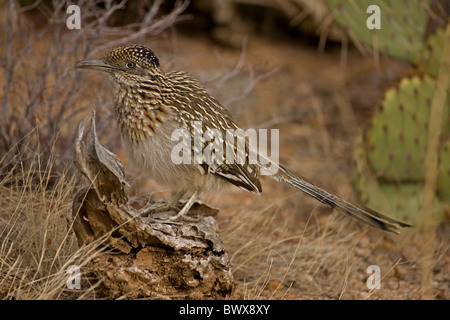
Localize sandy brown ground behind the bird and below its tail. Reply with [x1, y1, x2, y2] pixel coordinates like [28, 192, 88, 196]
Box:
[120, 33, 450, 299]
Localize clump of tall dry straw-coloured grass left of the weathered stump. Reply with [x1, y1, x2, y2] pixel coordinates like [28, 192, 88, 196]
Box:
[0, 141, 100, 299]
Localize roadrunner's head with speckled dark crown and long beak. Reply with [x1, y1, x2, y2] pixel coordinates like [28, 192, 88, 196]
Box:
[76, 45, 160, 85]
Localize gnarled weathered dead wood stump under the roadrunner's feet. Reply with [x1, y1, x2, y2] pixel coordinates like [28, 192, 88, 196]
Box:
[72, 112, 234, 299]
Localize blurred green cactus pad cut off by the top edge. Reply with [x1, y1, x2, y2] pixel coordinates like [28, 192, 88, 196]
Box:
[325, 0, 430, 62]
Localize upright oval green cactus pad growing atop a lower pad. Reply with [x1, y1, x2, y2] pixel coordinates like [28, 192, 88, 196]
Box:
[366, 76, 448, 181]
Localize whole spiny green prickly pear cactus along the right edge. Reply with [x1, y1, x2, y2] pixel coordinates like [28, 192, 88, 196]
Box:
[325, 0, 450, 223]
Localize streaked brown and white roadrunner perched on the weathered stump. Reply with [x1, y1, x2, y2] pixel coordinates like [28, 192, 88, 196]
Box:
[77, 45, 409, 233]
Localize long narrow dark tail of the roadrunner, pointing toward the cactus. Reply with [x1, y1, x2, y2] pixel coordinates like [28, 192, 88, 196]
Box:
[264, 163, 411, 234]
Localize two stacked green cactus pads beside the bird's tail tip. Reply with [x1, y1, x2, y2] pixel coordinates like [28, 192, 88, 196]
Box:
[354, 76, 450, 223]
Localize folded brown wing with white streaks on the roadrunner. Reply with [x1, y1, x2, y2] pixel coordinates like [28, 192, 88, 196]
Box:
[171, 72, 262, 193]
